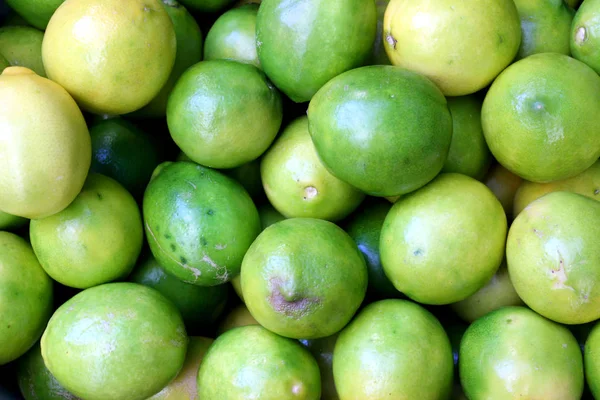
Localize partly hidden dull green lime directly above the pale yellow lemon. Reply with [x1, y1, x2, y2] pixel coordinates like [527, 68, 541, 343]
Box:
[0, 26, 46, 78]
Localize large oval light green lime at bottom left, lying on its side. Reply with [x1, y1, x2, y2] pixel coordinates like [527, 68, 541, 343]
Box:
[41, 282, 188, 400]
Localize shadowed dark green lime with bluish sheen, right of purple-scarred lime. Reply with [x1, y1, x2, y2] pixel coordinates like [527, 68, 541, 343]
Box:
[345, 197, 400, 298]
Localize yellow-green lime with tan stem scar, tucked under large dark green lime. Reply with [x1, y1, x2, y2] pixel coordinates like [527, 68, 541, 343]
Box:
[260, 116, 365, 221]
